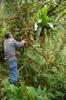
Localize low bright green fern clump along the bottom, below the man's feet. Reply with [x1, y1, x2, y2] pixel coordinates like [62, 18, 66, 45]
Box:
[3, 81, 54, 100]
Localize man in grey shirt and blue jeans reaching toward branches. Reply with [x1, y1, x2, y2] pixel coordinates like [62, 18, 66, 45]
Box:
[4, 32, 26, 84]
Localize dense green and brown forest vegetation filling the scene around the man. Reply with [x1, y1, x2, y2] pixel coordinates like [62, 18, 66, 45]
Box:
[0, 0, 66, 100]
